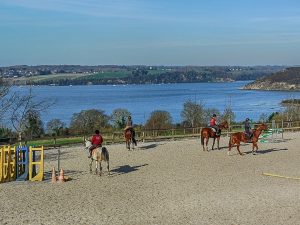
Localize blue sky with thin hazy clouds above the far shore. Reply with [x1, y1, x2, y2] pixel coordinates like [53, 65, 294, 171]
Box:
[0, 0, 300, 66]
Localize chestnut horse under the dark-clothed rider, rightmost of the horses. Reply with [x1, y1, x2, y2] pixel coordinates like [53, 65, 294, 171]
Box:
[228, 123, 268, 155]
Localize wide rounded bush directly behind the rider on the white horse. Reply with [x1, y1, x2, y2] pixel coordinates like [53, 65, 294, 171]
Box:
[70, 109, 109, 135]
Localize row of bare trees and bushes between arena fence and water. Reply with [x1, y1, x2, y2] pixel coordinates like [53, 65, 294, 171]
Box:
[0, 77, 300, 141]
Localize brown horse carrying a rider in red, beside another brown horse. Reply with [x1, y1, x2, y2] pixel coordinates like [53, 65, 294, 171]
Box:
[201, 120, 228, 151]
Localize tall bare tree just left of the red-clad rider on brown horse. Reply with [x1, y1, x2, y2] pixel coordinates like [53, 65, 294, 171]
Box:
[181, 100, 204, 127]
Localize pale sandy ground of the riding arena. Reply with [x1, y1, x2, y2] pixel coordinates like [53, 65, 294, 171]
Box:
[0, 132, 300, 225]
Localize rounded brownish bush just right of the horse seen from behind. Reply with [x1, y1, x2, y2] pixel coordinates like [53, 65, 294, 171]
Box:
[145, 110, 172, 129]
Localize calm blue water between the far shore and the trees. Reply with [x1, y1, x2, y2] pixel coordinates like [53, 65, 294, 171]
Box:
[11, 82, 300, 125]
